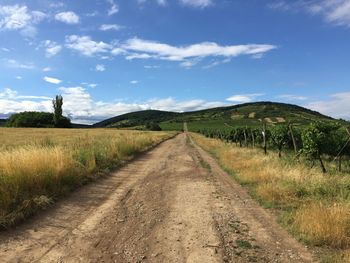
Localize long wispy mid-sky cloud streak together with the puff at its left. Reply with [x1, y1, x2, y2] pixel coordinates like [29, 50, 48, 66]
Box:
[65, 35, 277, 67]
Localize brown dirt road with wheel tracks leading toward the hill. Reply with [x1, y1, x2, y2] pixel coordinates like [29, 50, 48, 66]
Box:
[0, 133, 314, 263]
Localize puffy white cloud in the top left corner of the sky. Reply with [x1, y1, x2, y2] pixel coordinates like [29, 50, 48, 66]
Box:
[0, 5, 47, 37]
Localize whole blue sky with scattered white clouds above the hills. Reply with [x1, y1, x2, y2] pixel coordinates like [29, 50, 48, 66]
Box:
[0, 0, 350, 123]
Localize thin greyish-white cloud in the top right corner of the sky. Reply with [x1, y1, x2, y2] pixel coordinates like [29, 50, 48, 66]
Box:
[268, 0, 350, 27]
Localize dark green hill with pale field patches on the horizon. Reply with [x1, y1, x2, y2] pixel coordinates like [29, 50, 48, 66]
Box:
[93, 102, 342, 131]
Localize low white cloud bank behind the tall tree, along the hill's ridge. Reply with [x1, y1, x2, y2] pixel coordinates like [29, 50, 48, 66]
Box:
[0, 87, 227, 123]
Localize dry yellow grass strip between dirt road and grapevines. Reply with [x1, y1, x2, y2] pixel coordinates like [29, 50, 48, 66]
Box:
[191, 134, 350, 262]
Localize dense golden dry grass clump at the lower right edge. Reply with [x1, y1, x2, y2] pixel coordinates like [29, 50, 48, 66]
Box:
[293, 203, 350, 248]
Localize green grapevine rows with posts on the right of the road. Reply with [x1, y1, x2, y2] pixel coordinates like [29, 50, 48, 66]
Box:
[198, 122, 350, 173]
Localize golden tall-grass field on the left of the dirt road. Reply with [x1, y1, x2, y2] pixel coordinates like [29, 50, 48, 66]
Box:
[0, 128, 175, 227]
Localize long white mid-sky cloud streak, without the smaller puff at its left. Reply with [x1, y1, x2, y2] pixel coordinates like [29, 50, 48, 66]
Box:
[121, 38, 277, 66]
